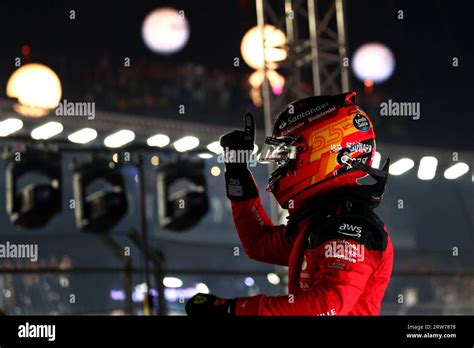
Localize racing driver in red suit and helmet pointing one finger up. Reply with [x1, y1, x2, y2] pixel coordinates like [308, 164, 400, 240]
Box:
[186, 92, 393, 317]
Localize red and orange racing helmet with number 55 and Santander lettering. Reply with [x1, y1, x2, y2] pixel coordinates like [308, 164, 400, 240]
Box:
[259, 92, 388, 208]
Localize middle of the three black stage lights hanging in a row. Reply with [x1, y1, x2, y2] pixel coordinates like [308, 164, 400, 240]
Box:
[73, 158, 128, 233]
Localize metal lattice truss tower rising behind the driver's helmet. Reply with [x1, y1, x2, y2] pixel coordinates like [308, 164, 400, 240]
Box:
[256, 0, 350, 293]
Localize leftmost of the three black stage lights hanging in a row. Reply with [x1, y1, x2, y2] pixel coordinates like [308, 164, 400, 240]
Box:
[5, 150, 62, 228]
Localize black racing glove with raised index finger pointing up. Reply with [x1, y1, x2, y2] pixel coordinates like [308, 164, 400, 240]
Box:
[220, 112, 258, 201]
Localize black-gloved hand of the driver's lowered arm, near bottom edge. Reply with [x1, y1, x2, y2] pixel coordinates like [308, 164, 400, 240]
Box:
[185, 293, 234, 317]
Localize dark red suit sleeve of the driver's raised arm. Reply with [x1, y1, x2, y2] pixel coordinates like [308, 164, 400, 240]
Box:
[231, 196, 294, 266]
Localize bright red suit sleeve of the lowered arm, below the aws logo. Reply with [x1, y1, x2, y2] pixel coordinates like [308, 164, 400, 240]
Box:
[235, 222, 383, 316]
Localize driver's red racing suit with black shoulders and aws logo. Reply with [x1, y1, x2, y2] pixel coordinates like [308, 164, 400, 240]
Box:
[231, 197, 393, 316]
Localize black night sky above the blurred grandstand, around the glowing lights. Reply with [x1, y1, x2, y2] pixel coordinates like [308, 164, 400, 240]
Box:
[0, 0, 474, 151]
